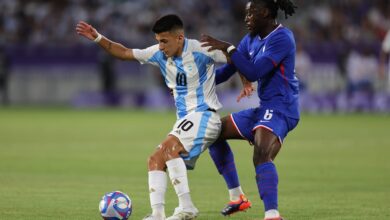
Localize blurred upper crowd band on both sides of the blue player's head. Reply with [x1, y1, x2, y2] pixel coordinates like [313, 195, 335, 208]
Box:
[0, 0, 390, 45]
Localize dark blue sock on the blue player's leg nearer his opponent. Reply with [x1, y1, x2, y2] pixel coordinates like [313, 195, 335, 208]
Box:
[209, 141, 240, 189]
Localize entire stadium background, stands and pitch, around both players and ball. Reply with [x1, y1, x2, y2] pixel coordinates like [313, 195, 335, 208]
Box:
[0, 0, 390, 220]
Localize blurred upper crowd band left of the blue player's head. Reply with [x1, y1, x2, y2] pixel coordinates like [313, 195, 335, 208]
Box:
[0, 0, 243, 46]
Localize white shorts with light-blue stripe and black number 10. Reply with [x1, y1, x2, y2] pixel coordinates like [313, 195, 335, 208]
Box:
[169, 111, 222, 169]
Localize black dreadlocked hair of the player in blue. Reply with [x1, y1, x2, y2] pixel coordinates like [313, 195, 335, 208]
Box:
[249, 0, 297, 19]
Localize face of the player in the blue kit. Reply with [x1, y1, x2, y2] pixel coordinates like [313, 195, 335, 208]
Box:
[245, 2, 267, 34]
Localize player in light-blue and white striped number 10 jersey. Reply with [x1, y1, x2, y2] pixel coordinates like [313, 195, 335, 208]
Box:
[76, 15, 250, 220]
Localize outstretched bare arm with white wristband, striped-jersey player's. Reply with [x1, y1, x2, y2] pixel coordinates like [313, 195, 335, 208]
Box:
[76, 21, 135, 60]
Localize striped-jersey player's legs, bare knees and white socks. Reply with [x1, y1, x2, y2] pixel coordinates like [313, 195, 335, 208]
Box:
[146, 135, 198, 219]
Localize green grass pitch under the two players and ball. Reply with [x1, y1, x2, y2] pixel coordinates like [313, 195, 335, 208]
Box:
[0, 108, 390, 220]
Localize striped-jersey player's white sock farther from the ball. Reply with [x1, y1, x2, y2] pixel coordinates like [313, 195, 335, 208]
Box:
[166, 158, 194, 209]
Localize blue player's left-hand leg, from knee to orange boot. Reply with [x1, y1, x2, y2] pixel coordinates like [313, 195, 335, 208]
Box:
[209, 116, 251, 216]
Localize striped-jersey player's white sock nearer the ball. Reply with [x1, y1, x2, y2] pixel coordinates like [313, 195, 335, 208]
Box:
[148, 170, 167, 218]
